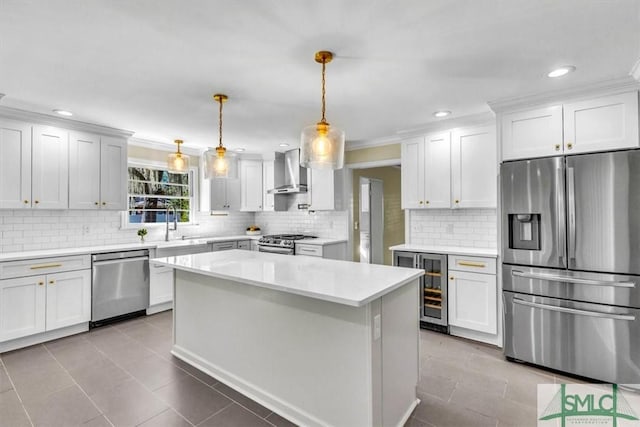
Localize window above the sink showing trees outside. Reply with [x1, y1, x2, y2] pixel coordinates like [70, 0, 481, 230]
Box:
[127, 165, 194, 224]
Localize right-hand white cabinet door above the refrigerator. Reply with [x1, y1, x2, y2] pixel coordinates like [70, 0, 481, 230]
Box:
[564, 91, 639, 154]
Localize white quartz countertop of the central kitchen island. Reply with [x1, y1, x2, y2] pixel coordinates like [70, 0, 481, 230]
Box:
[151, 249, 424, 307]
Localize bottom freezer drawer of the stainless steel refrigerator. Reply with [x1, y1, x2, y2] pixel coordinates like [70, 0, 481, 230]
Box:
[503, 291, 640, 384]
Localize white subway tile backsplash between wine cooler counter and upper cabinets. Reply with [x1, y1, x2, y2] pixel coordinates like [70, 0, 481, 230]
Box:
[409, 209, 498, 248]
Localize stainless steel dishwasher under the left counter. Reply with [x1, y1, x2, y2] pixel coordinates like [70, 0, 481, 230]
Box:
[91, 249, 149, 326]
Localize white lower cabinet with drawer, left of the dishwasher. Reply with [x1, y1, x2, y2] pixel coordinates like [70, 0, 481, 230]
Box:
[0, 257, 91, 342]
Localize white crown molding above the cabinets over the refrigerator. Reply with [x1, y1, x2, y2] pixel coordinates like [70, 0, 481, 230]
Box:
[487, 75, 640, 113]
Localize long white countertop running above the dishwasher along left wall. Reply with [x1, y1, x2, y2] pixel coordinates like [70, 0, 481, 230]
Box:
[0, 234, 261, 262]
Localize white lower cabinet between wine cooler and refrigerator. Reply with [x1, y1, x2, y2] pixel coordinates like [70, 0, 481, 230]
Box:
[447, 255, 498, 334]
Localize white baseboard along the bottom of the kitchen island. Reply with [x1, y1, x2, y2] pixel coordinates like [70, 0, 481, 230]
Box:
[171, 345, 330, 426]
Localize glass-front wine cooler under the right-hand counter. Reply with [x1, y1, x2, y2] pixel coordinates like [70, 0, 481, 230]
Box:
[393, 252, 449, 333]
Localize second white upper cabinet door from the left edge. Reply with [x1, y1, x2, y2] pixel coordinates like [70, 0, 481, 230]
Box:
[31, 126, 69, 209]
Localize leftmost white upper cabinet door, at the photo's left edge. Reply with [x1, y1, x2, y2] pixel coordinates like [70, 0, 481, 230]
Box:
[0, 119, 31, 209]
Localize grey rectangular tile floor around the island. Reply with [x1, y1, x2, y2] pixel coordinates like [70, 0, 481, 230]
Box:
[0, 312, 584, 427]
